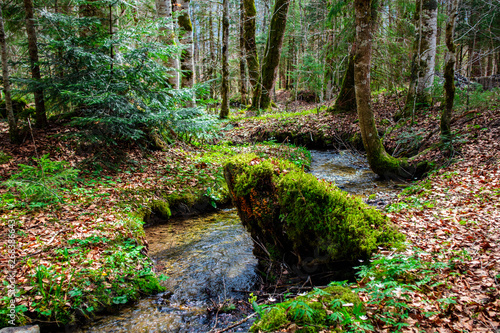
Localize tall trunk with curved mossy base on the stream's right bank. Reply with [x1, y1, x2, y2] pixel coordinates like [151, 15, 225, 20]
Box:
[354, 0, 411, 178]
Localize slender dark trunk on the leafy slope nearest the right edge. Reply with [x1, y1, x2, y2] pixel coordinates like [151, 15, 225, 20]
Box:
[441, 0, 458, 143]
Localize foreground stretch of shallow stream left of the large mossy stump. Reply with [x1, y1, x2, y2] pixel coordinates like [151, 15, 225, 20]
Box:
[80, 209, 257, 333]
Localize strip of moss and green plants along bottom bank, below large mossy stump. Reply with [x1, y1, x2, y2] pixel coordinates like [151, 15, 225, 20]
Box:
[254, 248, 468, 332]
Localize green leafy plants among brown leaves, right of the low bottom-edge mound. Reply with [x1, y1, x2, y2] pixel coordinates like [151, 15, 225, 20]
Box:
[354, 248, 460, 332]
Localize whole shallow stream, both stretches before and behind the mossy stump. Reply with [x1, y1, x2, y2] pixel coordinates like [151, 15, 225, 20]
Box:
[77, 151, 397, 333]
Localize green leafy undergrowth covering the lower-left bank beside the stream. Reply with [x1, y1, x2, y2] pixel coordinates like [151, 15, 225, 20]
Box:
[0, 213, 164, 327]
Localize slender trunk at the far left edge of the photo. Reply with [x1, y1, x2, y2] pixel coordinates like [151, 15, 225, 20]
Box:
[0, 6, 19, 143]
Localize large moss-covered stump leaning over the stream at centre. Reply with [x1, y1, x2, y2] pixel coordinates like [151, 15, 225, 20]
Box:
[224, 154, 404, 272]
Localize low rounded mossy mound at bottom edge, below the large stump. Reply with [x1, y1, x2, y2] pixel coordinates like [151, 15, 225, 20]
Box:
[250, 286, 364, 332]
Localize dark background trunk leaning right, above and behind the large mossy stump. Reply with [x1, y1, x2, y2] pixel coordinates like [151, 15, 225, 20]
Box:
[252, 0, 290, 109]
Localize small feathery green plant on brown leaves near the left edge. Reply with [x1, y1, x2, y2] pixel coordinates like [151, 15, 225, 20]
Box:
[3, 154, 80, 203]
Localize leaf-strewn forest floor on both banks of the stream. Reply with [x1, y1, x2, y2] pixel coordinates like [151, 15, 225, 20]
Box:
[0, 89, 500, 333]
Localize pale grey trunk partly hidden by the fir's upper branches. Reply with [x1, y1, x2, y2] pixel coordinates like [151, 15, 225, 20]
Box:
[156, 0, 179, 89]
